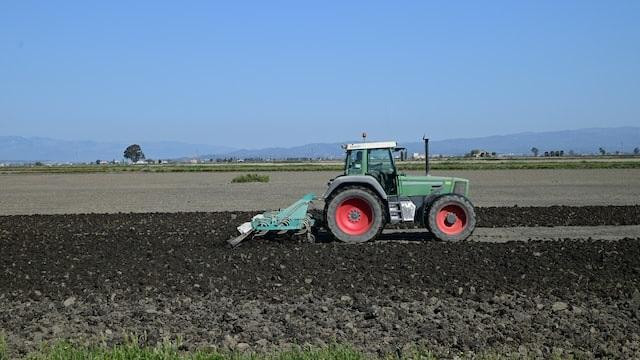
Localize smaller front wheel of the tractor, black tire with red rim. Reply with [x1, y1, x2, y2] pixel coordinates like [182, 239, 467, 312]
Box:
[425, 194, 476, 241]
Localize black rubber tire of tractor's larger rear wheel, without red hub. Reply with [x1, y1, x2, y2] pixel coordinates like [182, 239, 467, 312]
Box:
[324, 186, 386, 243]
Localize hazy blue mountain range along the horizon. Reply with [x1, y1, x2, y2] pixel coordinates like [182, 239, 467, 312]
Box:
[0, 127, 640, 162]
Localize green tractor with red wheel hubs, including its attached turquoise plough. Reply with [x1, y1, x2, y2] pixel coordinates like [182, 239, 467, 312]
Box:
[229, 139, 476, 246]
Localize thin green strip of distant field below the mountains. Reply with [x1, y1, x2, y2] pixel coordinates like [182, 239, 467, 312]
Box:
[0, 157, 640, 174]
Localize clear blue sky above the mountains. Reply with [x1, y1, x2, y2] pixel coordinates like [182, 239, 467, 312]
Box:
[0, 0, 640, 148]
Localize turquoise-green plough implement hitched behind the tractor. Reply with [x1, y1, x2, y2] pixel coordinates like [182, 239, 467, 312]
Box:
[227, 193, 316, 247]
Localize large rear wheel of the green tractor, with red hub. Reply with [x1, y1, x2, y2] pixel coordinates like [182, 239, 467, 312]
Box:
[325, 187, 385, 243]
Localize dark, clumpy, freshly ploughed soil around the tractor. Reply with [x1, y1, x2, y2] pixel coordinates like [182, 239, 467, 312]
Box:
[0, 207, 640, 357]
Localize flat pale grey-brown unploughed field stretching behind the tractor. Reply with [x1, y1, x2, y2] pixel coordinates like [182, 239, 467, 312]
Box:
[0, 169, 640, 215]
